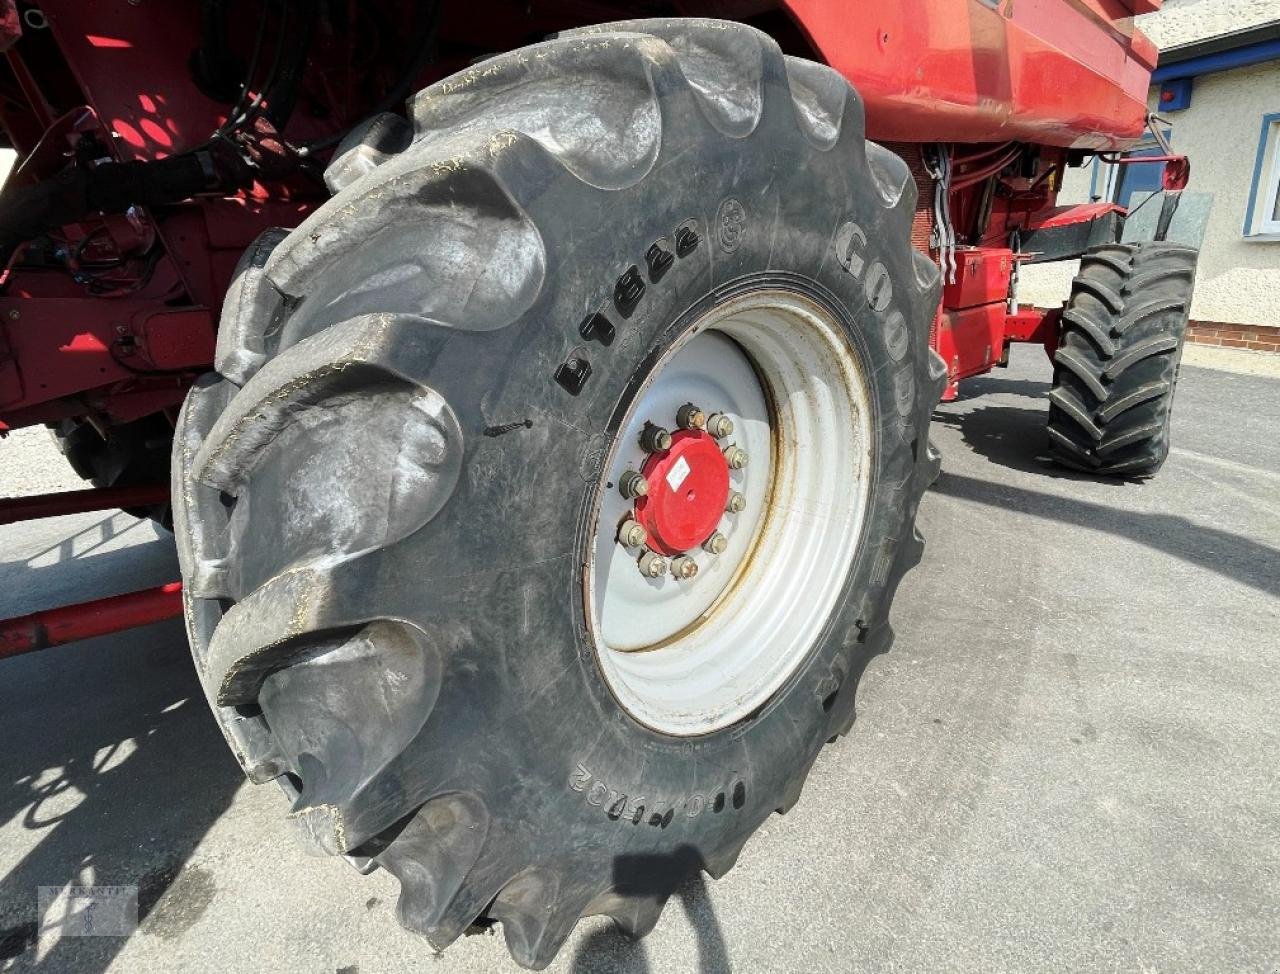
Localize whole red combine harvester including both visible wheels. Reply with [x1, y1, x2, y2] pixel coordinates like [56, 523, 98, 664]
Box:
[0, 0, 1196, 968]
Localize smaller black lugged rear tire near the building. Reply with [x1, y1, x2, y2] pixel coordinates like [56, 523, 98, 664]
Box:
[1048, 243, 1198, 476]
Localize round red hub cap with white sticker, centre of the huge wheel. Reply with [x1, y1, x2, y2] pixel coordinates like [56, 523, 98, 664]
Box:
[636, 430, 728, 555]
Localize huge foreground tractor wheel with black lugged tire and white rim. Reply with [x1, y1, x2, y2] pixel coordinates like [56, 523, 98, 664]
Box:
[174, 20, 945, 968]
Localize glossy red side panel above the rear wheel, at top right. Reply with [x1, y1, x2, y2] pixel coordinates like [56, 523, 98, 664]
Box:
[786, 0, 1158, 148]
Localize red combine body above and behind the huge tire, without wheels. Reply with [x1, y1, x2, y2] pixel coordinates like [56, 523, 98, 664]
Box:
[0, 0, 1160, 645]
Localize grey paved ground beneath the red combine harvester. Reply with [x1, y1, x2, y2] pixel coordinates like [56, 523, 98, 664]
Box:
[0, 349, 1280, 974]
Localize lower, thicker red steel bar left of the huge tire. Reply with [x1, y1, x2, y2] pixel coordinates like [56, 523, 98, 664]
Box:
[0, 581, 182, 659]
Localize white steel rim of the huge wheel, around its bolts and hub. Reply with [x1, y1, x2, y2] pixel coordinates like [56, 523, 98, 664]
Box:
[585, 289, 874, 736]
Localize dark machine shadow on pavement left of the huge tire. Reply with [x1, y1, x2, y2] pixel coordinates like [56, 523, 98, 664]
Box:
[0, 515, 244, 973]
